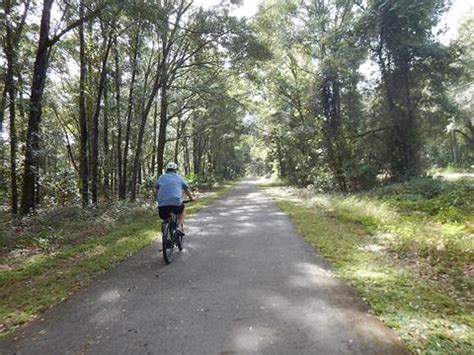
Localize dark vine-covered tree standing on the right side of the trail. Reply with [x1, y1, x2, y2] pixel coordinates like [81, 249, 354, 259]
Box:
[365, 0, 446, 180]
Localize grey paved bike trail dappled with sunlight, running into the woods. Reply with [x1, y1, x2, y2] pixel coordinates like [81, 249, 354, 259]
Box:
[0, 182, 407, 355]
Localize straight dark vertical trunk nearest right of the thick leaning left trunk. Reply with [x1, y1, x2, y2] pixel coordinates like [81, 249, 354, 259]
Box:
[79, 1, 89, 207]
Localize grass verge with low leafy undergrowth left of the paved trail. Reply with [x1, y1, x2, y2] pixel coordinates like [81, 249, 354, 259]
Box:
[0, 184, 232, 337]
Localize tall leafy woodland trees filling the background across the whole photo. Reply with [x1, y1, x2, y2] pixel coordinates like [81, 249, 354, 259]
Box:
[0, 0, 474, 214]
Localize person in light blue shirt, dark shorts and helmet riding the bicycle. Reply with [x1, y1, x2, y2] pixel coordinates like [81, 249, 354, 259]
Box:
[155, 162, 194, 234]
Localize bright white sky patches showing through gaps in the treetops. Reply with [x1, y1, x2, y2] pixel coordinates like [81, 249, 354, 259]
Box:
[194, 0, 474, 44]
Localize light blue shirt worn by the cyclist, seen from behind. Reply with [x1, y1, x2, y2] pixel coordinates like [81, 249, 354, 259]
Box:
[155, 173, 189, 207]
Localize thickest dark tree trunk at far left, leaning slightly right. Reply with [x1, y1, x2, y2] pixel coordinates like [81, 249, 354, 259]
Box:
[21, 0, 53, 214]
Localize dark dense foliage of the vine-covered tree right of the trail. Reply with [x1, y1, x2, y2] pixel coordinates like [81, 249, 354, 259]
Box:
[363, 0, 453, 180]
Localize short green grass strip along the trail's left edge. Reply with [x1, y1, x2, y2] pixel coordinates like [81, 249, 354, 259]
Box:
[0, 184, 233, 337]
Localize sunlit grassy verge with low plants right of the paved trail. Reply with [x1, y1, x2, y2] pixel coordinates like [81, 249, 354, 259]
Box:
[267, 179, 474, 354]
